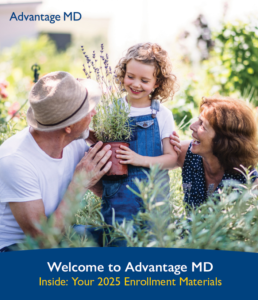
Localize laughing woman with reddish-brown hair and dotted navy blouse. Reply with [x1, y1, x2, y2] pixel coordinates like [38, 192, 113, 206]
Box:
[171, 97, 258, 207]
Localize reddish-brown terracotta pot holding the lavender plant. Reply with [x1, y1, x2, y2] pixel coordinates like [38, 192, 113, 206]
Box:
[103, 142, 129, 180]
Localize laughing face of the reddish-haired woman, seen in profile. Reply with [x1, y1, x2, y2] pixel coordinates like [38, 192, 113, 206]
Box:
[190, 113, 215, 156]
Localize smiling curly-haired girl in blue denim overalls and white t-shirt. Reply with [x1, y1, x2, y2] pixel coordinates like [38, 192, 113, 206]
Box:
[102, 43, 177, 230]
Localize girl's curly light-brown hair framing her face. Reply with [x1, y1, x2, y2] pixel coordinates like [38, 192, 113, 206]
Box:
[115, 43, 178, 102]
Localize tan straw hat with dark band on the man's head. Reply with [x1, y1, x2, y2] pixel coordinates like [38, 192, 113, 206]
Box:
[27, 71, 101, 131]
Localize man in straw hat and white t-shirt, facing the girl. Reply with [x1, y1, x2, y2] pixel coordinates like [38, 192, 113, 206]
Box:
[0, 72, 111, 252]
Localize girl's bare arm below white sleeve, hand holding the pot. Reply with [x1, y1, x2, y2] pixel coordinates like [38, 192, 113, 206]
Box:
[116, 138, 178, 169]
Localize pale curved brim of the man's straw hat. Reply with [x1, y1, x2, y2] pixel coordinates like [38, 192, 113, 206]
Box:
[27, 78, 101, 131]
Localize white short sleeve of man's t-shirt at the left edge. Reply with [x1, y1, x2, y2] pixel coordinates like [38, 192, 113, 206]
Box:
[0, 155, 42, 202]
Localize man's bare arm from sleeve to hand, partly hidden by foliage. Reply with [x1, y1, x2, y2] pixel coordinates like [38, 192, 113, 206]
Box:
[9, 142, 112, 238]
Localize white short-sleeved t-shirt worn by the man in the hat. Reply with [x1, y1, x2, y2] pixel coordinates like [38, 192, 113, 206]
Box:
[0, 127, 88, 249]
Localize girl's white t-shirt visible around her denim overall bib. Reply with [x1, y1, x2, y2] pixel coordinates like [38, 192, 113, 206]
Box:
[123, 97, 175, 151]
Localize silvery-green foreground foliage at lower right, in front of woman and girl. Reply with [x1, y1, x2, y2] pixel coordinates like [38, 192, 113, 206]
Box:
[105, 168, 258, 252]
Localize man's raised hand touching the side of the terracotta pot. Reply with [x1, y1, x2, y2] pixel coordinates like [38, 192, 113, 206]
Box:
[74, 142, 112, 189]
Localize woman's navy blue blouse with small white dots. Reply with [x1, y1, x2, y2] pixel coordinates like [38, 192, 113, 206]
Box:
[182, 143, 258, 207]
